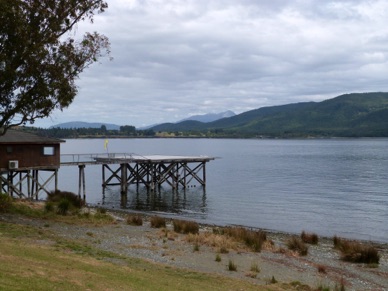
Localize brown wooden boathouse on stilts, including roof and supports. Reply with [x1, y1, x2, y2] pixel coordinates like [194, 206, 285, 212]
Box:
[0, 130, 64, 199]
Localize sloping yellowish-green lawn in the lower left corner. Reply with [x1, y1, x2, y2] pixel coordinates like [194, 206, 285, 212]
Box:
[0, 222, 264, 290]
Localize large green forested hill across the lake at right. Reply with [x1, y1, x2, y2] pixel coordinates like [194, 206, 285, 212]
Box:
[152, 92, 388, 137]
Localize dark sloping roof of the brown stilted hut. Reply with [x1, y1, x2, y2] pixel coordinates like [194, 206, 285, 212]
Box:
[0, 129, 65, 144]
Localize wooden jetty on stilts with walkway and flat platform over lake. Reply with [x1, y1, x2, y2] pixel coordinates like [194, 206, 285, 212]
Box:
[61, 153, 215, 198]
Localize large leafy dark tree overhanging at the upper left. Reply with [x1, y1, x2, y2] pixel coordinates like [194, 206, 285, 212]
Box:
[0, 0, 110, 135]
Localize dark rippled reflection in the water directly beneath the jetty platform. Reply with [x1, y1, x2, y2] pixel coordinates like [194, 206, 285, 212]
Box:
[102, 186, 207, 218]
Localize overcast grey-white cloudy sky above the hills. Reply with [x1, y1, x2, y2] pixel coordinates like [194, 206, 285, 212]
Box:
[35, 0, 388, 127]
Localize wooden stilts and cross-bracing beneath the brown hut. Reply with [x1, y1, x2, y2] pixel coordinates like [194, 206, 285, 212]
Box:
[0, 169, 58, 200]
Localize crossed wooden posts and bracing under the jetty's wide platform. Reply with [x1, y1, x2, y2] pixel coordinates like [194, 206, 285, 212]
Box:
[102, 160, 206, 192]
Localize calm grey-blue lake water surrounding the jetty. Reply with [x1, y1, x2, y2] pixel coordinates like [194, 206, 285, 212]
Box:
[55, 139, 388, 242]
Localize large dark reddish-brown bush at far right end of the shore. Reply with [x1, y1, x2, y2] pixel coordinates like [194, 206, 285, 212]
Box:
[333, 236, 380, 264]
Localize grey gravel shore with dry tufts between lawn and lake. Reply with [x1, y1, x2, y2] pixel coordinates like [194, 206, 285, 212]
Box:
[0, 211, 388, 290]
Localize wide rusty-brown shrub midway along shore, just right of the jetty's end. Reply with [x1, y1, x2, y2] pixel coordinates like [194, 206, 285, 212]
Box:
[224, 227, 267, 252]
